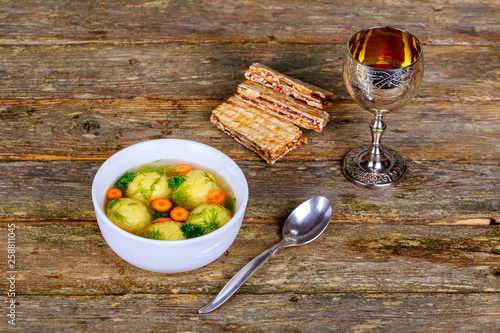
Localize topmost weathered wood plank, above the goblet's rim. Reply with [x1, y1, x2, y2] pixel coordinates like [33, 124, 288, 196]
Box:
[0, 0, 499, 45]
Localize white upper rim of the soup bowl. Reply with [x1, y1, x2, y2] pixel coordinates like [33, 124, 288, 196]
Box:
[92, 139, 248, 247]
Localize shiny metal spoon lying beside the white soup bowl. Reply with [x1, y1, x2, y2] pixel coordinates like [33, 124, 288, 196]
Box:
[198, 197, 332, 313]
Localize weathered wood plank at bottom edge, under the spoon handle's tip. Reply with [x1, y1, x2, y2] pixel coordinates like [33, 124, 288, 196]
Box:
[0, 292, 500, 333]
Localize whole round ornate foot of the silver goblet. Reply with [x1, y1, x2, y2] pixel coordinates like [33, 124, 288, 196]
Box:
[342, 145, 406, 188]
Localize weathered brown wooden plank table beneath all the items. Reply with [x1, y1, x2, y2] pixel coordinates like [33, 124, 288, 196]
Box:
[0, 0, 500, 332]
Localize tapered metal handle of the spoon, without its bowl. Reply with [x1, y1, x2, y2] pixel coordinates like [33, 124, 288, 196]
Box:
[198, 245, 277, 313]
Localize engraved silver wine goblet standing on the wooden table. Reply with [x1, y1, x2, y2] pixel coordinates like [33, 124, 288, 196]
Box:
[342, 27, 424, 188]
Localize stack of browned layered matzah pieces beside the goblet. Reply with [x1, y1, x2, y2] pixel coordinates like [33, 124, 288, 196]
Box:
[210, 64, 335, 164]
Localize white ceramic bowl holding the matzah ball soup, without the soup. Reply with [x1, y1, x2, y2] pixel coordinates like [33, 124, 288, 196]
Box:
[92, 139, 248, 273]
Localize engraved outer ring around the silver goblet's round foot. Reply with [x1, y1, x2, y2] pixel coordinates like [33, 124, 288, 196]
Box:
[342, 146, 406, 187]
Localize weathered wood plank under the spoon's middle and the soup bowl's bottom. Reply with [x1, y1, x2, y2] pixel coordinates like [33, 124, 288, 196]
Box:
[0, 221, 500, 295]
